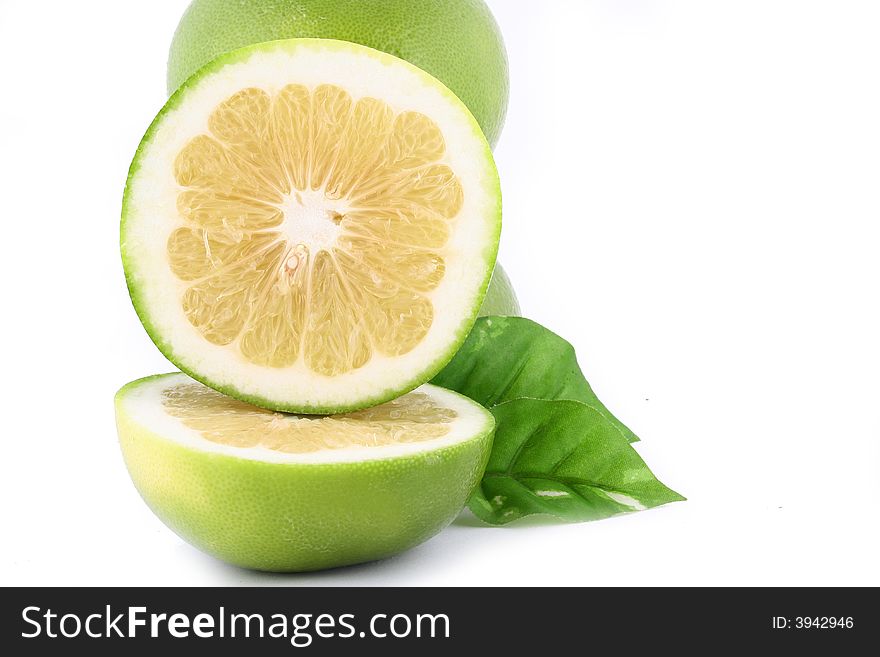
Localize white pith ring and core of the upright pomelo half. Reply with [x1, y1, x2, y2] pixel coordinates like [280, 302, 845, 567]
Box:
[123, 42, 499, 408]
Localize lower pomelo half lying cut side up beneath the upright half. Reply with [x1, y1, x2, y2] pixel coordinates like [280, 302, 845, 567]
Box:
[116, 374, 495, 572]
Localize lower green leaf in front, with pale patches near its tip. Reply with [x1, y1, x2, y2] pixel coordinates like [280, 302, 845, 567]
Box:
[468, 399, 685, 525]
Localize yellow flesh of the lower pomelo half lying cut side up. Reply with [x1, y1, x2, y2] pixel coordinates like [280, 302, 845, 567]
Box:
[162, 383, 458, 454]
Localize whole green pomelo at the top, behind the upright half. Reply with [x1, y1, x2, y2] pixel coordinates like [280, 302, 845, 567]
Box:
[168, 0, 509, 146]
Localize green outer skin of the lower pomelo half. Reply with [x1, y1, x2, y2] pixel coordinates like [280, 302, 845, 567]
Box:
[116, 382, 494, 572]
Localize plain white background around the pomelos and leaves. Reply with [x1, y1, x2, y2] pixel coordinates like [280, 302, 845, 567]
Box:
[0, 0, 880, 586]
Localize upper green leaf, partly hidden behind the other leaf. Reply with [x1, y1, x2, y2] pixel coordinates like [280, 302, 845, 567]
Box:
[432, 317, 638, 442]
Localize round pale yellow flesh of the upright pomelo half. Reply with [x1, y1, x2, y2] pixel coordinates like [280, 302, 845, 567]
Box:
[167, 85, 464, 376]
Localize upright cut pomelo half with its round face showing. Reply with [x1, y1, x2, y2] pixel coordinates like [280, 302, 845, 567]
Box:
[121, 39, 501, 413]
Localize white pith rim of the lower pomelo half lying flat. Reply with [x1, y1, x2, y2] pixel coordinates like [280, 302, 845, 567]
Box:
[119, 374, 493, 464]
